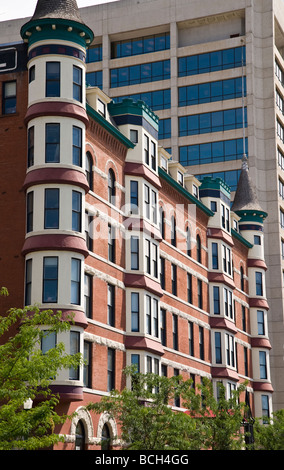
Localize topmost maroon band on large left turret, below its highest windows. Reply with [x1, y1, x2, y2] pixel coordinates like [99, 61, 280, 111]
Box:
[25, 101, 89, 127]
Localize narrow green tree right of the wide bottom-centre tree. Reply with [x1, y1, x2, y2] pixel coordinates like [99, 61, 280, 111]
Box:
[184, 378, 246, 450]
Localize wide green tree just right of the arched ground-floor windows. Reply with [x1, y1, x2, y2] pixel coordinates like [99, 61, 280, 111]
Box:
[87, 368, 200, 451]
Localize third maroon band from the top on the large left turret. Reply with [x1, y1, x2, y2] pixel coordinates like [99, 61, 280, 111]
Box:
[22, 233, 89, 258]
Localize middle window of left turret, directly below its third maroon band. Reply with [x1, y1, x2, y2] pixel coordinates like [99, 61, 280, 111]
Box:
[42, 256, 58, 303]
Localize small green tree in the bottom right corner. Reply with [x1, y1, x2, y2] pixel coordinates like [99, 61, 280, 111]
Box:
[254, 409, 284, 450]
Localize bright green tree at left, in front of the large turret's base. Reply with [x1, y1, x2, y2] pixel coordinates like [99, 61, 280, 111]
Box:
[0, 288, 82, 450]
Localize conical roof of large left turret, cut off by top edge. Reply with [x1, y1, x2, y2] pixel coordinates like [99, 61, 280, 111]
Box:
[31, 0, 83, 23]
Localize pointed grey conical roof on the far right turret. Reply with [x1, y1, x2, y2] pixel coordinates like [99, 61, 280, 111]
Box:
[232, 155, 263, 212]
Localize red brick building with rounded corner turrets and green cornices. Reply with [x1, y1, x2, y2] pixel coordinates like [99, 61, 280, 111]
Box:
[0, 1, 273, 449]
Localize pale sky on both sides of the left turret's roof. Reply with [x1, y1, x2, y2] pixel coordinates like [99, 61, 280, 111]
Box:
[0, 0, 117, 21]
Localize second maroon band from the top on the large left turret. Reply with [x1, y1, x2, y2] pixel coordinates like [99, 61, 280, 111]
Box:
[23, 167, 90, 193]
